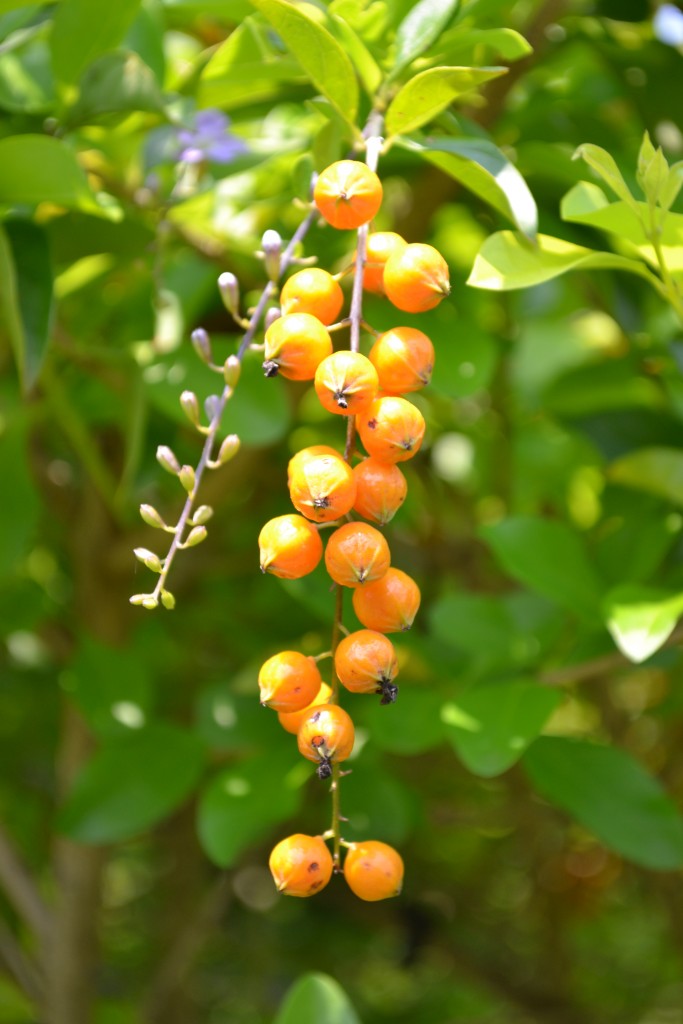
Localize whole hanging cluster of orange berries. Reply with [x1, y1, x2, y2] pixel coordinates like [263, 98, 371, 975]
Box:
[253, 160, 450, 900]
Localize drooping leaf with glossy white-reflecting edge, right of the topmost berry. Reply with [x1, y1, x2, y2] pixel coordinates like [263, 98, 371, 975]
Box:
[401, 136, 538, 238]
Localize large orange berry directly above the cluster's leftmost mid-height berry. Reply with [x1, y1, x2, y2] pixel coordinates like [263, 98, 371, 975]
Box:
[289, 454, 355, 522]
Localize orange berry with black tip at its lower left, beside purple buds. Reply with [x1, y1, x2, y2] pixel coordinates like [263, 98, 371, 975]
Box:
[263, 313, 332, 381]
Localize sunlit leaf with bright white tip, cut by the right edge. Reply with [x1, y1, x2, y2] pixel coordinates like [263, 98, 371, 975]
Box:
[604, 584, 683, 664]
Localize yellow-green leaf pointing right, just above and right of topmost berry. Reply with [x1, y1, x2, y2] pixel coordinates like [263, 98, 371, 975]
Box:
[385, 68, 508, 137]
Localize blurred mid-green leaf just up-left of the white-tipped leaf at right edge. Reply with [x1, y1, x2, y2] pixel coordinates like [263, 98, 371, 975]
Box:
[479, 516, 602, 618]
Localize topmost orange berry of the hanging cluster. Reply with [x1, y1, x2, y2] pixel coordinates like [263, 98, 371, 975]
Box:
[313, 160, 382, 228]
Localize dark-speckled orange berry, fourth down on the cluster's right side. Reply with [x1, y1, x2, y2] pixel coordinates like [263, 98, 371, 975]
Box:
[355, 395, 425, 463]
